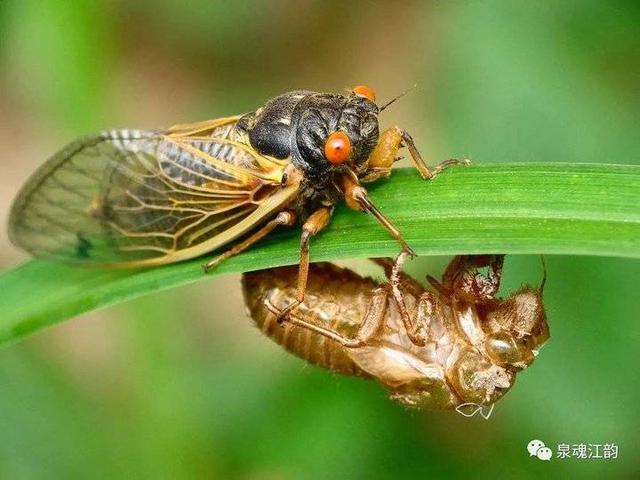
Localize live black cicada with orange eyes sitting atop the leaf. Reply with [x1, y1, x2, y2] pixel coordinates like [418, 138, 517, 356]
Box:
[9, 86, 459, 318]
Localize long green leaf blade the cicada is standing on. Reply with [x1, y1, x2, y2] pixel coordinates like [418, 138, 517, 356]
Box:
[0, 163, 640, 345]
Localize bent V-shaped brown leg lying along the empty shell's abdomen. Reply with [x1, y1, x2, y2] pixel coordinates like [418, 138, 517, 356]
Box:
[264, 286, 389, 348]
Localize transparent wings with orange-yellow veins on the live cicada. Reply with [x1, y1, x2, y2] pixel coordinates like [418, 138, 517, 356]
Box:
[9, 117, 297, 266]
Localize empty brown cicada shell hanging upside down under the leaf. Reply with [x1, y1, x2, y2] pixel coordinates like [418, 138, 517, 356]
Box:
[242, 253, 549, 414]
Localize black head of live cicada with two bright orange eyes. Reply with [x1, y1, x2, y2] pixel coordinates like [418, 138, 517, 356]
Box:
[291, 86, 379, 179]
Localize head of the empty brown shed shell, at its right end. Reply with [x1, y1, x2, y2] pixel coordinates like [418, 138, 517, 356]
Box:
[485, 287, 549, 369]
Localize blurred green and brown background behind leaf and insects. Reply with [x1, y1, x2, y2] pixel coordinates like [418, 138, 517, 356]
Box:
[0, 0, 640, 479]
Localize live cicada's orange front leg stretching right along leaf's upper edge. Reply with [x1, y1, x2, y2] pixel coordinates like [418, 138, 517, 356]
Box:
[361, 126, 471, 182]
